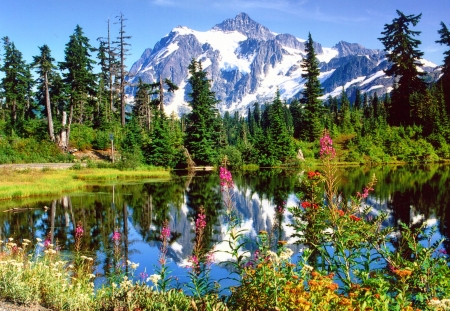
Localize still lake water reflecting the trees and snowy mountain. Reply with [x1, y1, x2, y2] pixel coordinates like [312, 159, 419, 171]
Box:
[0, 165, 450, 287]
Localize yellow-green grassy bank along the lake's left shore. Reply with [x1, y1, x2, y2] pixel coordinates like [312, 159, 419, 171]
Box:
[0, 168, 170, 200]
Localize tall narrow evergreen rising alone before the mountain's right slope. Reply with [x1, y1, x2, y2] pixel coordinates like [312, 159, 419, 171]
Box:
[300, 33, 322, 141]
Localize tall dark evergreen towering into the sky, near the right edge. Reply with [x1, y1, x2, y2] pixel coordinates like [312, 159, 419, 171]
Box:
[379, 10, 426, 125]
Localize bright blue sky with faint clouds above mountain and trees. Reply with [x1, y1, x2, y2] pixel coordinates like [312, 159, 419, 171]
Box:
[0, 0, 450, 67]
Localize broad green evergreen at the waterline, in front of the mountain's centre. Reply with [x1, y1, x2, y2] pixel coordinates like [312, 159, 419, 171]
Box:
[185, 59, 219, 164]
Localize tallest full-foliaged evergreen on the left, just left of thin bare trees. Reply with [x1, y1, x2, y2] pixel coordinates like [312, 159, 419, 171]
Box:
[59, 25, 95, 144]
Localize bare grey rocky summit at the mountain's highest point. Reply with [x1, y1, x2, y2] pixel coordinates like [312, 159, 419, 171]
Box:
[213, 13, 275, 40]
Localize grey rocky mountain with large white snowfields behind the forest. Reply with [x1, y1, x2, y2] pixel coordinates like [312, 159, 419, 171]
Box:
[129, 13, 437, 114]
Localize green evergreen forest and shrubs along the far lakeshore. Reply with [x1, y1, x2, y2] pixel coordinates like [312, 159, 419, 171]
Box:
[0, 11, 450, 168]
